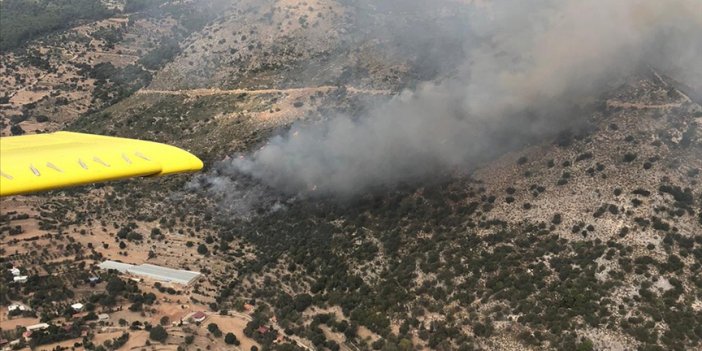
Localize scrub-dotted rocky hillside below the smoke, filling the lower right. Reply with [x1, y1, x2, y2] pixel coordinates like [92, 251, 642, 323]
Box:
[177, 70, 702, 349]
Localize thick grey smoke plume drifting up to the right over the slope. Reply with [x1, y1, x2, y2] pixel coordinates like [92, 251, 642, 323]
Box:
[220, 0, 702, 196]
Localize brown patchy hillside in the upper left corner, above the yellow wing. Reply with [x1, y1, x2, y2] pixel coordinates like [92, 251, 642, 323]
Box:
[0, 0, 224, 135]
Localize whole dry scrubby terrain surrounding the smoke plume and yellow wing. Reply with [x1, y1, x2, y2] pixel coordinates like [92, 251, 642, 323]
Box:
[0, 0, 702, 351]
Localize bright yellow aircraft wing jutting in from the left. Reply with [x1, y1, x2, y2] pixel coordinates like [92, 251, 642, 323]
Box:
[0, 132, 202, 196]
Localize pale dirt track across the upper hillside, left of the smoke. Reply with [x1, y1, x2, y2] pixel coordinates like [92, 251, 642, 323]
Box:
[136, 85, 392, 97]
